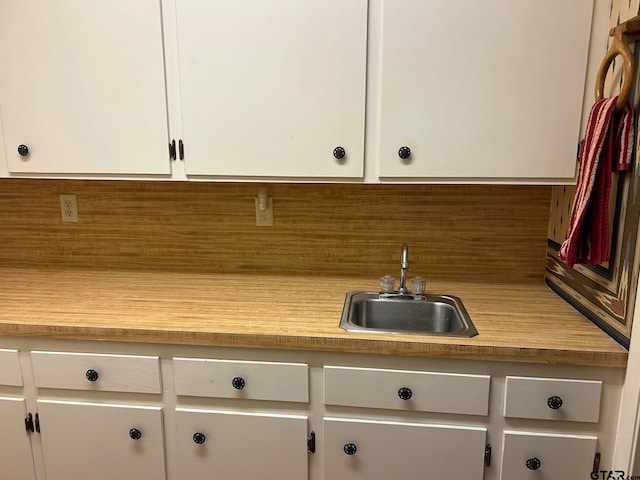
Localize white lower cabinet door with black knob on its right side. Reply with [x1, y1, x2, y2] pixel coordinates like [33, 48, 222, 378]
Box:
[37, 400, 166, 480]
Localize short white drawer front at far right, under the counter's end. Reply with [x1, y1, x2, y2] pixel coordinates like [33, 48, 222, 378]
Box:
[504, 377, 602, 423]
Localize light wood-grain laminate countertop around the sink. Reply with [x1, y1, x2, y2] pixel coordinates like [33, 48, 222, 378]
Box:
[0, 268, 627, 367]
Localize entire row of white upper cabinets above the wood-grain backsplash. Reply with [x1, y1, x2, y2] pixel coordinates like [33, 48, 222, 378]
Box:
[0, 0, 596, 183]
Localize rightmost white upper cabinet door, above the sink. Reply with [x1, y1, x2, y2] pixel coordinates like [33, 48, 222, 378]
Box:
[378, 0, 593, 181]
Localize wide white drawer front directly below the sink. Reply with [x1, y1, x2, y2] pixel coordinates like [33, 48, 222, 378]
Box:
[324, 366, 491, 415]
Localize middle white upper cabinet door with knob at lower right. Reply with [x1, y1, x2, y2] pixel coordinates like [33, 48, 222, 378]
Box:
[176, 0, 367, 178]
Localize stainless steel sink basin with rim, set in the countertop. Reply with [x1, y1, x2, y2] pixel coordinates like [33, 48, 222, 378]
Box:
[340, 292, 478, 337]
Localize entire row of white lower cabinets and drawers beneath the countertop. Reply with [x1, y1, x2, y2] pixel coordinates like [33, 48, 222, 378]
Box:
[0, 337, 625, 480]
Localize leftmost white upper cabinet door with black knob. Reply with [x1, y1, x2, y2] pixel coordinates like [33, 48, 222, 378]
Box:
[0, 0, 170, 174]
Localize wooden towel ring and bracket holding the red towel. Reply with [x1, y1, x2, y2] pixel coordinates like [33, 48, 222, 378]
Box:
[596, 15, 640, 110]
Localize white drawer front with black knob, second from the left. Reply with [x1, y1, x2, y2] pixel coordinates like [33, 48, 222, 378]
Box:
[31, 352, 162, 393]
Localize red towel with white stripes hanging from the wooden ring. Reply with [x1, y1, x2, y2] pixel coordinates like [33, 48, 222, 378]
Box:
[558, 97, 633, 267]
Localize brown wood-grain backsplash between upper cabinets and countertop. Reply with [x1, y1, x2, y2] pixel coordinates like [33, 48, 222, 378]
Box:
[0, 179, 551, 282]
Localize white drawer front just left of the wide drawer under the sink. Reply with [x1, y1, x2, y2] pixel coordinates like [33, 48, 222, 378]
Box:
[173, 358, 309, 403]
